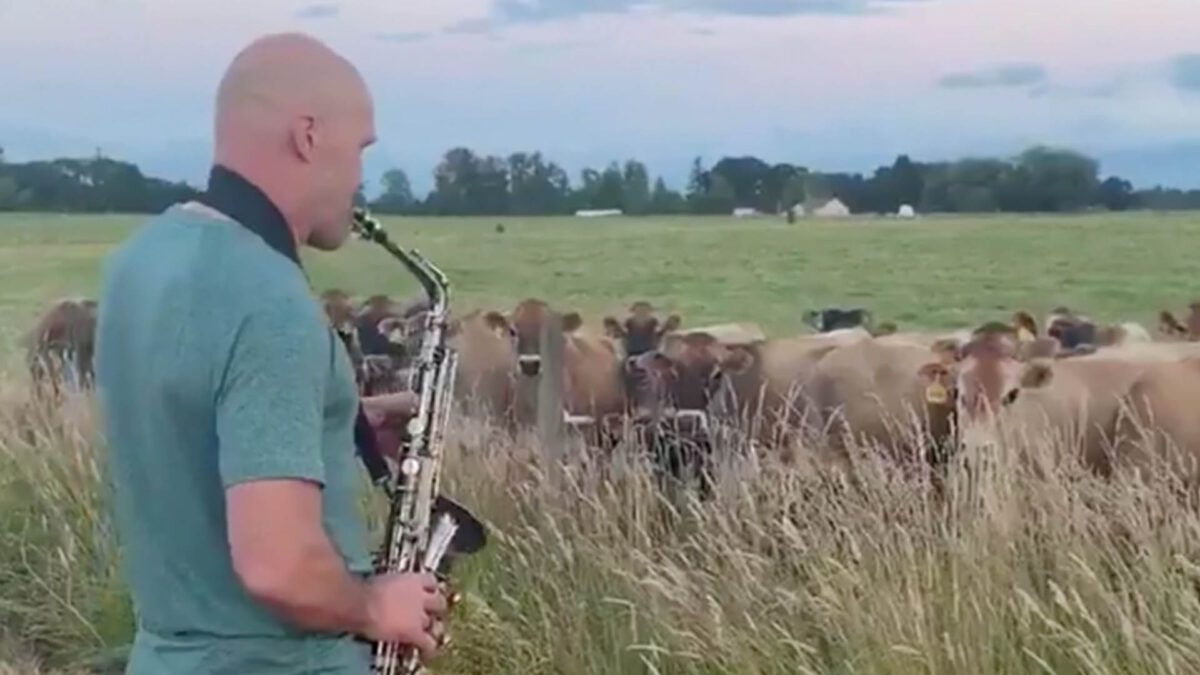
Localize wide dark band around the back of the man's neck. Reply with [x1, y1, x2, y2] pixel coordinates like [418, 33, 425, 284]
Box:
[197, 165, 304, 269]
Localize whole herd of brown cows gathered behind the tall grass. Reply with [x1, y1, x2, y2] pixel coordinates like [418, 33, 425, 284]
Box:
[14, 291, 1200, 487]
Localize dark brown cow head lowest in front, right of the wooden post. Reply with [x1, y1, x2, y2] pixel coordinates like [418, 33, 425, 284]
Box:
[625, 333, 756, 419]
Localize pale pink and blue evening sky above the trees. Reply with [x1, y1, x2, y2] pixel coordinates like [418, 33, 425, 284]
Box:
[0, 0, 1200, 193]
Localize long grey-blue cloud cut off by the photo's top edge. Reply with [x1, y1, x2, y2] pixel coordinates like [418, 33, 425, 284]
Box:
[482, 0, 925, 23]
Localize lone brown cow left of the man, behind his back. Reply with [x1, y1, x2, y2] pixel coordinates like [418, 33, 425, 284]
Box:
[20, 298, 98, 396]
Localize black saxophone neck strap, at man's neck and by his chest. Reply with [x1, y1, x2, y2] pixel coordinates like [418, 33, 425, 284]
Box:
[196, 165, 390, 484]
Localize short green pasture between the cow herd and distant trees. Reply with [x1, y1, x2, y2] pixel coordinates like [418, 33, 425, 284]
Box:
[7, 214, 1200, 367]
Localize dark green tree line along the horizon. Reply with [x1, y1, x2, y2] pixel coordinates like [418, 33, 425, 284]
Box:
[0, 147, 1200, 215]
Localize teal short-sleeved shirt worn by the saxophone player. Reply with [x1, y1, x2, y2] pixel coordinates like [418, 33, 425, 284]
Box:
[96, 165, 370, 675]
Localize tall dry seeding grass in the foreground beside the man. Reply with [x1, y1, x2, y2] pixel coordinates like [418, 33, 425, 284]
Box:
[0, 379, 1200, 675]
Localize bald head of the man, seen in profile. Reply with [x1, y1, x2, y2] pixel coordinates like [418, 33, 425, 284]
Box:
[214, 34, 374, 250]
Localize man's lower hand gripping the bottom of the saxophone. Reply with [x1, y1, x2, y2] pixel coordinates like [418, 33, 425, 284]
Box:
[362, 574, 449, 663]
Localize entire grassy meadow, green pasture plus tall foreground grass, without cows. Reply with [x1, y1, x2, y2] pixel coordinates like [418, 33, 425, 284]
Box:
[0, 214, 1200, 674]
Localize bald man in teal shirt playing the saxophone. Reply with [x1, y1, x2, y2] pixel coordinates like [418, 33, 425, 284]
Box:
[96, 34, 446, 675]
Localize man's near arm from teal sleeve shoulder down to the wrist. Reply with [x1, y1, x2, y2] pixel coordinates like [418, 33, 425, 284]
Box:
[217, 300, 367, 633]
